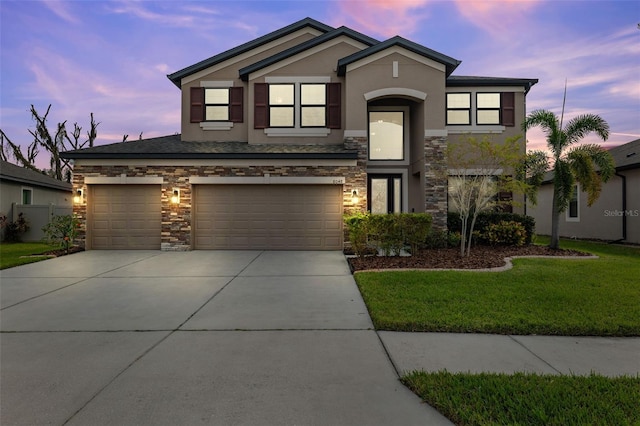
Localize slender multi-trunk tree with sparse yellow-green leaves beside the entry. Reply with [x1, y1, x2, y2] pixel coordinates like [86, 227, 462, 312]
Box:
[447, 136, 529, 256]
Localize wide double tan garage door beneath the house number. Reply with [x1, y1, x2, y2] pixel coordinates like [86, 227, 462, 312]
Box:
[194, 185, 343, 250]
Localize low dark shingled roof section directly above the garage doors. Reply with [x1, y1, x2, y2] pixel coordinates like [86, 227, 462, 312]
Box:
[61, 134, 358, 159]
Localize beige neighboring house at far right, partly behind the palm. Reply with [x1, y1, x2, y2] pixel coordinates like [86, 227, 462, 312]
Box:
[527, 139, 640, 244]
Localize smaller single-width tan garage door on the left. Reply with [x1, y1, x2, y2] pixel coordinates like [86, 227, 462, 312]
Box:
[87, 185, 162, 250]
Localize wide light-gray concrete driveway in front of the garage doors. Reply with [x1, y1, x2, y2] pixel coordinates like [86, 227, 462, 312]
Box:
[0, 251, 449, 425]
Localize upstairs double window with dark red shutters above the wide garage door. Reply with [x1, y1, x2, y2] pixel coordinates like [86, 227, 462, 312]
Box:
[254, 77, 342, 132]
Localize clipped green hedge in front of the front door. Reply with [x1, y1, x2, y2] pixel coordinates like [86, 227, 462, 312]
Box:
[344, 213, 432, 257]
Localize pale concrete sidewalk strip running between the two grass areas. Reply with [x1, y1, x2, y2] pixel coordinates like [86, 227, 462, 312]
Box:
[378, 331, 640, 377]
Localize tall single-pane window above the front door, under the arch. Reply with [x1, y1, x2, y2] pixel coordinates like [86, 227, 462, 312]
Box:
[369, 111, 404, 160]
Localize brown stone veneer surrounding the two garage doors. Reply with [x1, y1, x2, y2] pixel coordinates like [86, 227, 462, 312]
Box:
[73, 157, 367, 251]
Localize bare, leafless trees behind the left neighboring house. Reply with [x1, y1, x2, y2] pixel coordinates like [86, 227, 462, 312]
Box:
[0, 105, 100, 182]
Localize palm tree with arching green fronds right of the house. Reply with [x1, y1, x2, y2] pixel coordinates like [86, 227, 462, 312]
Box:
[522, 110, 615, 249]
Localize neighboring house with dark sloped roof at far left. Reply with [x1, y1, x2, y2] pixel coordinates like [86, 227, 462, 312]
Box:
[0, 161, 72, 241]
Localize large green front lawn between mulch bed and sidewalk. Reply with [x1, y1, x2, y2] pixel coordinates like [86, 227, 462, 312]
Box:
[355, 241, 640, 336]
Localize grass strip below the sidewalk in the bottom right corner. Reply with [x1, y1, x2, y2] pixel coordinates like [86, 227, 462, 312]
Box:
[402, 371, 640, 426]
